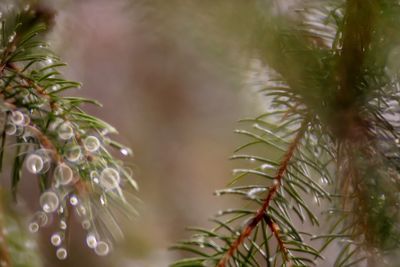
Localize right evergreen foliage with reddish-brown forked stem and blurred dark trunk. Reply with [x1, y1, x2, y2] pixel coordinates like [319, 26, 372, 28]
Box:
[172, 0, 400, 267]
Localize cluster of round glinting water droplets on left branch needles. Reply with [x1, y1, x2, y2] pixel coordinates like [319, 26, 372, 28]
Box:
[15, 115, 129, 260]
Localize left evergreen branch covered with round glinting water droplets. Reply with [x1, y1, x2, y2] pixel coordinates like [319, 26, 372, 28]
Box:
[0, 1, 137, 267]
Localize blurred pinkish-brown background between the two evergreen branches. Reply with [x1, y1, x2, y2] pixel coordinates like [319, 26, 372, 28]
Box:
[14, 0, 272, 267]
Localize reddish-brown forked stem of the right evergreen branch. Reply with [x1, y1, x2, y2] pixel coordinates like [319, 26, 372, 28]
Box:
[217, 119, 309, 267]
